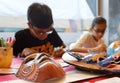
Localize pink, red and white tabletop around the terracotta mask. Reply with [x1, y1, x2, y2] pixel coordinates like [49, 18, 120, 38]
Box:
[0, 58, 119, 83]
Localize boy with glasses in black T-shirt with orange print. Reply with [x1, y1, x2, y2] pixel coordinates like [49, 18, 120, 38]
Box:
[13, 3, 65, 56]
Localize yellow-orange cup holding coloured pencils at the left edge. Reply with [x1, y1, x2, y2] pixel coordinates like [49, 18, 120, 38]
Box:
[0, 37, 13, 68]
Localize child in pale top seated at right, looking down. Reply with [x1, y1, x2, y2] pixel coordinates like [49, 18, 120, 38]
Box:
[70, 17, 107, 53]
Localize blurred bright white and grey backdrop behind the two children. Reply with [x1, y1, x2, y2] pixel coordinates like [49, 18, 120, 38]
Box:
[0, 0, 120, 45]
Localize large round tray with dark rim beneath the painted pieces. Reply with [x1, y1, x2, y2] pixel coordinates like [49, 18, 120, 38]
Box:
[62, 52, 120, 74]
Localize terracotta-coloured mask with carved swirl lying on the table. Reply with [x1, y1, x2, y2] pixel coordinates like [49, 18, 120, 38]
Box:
[16, 53, 65, 82]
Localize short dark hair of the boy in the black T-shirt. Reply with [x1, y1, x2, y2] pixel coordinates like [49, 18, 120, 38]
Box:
[27, 3, 53, 28]
